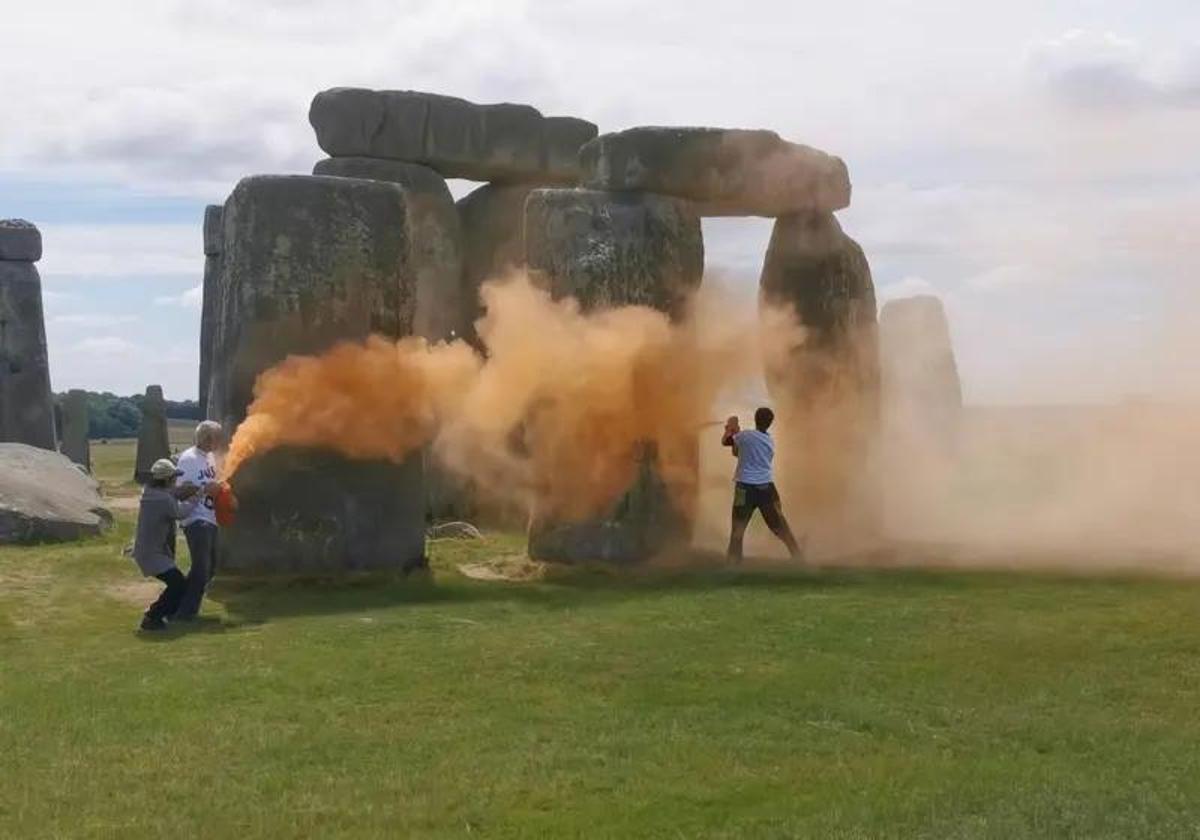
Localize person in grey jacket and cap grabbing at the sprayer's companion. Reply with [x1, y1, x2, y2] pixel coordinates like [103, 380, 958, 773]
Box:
[133, 458, 200, 630]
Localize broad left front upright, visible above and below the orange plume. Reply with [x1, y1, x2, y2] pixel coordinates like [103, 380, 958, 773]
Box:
[209, 175, 430, 575]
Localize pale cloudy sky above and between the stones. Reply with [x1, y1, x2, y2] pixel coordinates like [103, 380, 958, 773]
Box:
[0, 0, 1200, 403]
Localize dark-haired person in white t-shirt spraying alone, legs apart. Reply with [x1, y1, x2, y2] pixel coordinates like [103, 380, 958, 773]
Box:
[721, 407, 803, 562]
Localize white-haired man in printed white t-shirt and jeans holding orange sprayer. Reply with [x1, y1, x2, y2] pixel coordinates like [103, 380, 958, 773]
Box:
[174, 420, 224, 622]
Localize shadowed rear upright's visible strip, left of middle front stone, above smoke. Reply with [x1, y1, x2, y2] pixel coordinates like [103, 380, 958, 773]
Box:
[456, 184, 534, 342]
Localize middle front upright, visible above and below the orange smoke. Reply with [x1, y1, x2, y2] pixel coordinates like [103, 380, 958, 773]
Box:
[526, 190, 704, 563]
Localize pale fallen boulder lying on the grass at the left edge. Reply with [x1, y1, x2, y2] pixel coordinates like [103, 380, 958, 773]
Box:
[0, 443, 113, 544]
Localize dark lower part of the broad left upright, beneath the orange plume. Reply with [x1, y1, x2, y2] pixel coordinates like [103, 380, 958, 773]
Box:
[221, 448, 425, 576]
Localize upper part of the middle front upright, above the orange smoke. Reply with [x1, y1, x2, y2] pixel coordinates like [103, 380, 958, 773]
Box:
[524, 190, 704, 317]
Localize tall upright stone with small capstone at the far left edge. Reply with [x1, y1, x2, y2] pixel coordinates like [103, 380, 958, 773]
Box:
[0, 218, 56, 450]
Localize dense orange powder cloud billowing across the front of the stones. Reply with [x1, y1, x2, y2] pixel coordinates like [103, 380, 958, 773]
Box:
[224, 275, 787, 517]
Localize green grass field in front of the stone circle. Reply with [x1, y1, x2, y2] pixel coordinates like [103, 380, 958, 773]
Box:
[0, 444, 1200, 840]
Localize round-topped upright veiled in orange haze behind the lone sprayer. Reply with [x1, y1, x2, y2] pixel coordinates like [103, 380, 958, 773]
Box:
[760, 214, 880, 533]
